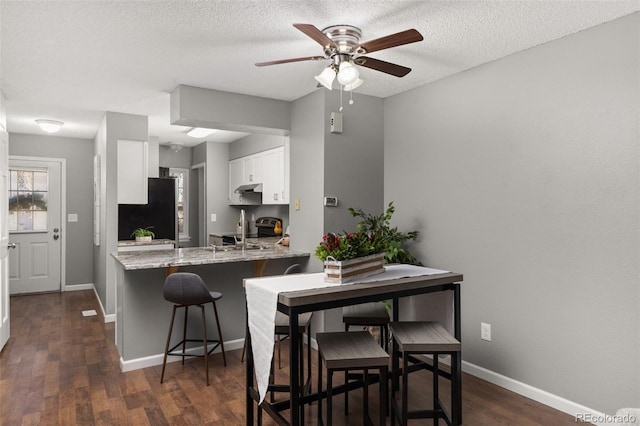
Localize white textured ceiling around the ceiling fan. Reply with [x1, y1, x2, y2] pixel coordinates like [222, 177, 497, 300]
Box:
[0, 0, 639, 144]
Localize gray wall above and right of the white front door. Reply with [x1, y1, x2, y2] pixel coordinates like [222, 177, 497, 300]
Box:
[9, 133, 93, 285]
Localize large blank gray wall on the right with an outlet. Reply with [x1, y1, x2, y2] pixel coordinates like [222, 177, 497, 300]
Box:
[384, 14, 640, 413]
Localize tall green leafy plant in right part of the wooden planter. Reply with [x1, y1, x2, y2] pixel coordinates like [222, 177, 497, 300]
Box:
[349, 201, 422, 265]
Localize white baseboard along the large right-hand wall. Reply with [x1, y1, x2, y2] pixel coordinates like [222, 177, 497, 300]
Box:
[462, 361, 610, 426]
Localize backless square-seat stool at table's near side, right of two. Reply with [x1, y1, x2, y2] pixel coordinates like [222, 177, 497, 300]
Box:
[389, 321, 460, 426]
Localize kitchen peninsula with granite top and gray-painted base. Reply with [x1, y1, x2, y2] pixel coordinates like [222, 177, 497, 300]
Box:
[112, 244, 309, 371]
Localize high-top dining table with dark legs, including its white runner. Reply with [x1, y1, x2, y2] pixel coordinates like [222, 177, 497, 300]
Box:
[244, 265, 463, 425]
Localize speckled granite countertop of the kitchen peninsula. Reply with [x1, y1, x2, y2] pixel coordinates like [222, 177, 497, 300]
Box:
[112, 245, 309, 270]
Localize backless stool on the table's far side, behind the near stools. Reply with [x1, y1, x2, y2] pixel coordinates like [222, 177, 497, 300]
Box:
[342, 302, 391, 415]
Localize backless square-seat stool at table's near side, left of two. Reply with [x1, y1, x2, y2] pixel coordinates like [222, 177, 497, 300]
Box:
[316, 331, 389, 426]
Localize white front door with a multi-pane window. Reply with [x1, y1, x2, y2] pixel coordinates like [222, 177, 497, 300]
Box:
[8, 158, 62, 294]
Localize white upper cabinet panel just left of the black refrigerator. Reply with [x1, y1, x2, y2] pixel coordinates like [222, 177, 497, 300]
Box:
[117, 140, 149, 204]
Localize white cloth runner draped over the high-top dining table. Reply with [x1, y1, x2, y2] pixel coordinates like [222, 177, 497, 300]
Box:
[244, 265, 449, 403]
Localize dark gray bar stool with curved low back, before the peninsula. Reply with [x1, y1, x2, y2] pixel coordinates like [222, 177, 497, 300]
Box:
[160, 272, 227, 386]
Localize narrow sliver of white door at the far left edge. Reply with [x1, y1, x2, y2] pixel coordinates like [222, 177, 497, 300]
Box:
[0, 128, 9, 351]
